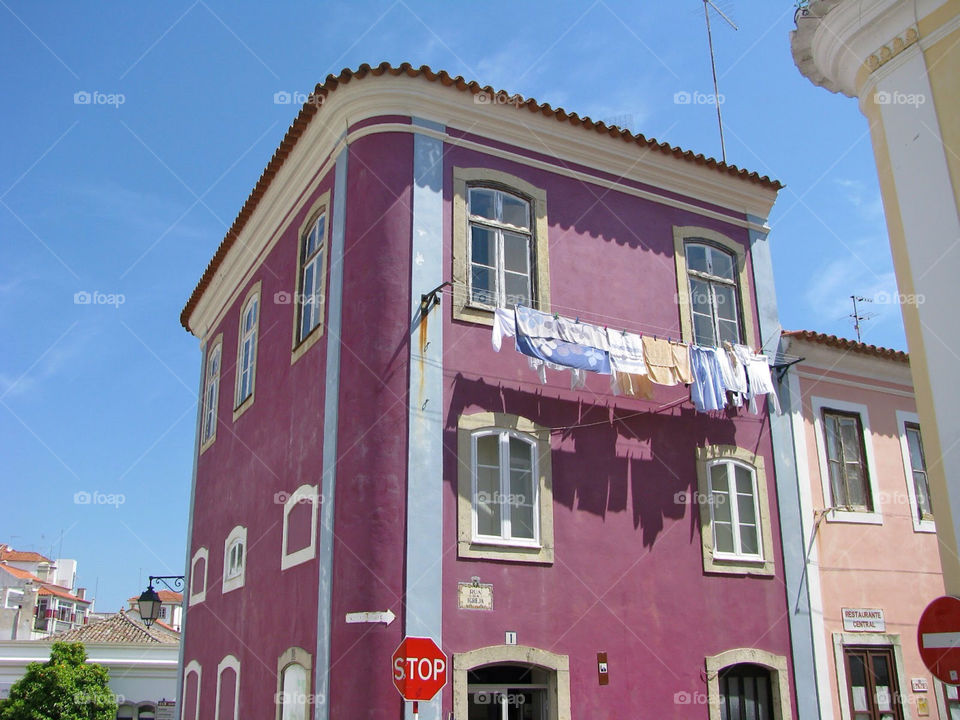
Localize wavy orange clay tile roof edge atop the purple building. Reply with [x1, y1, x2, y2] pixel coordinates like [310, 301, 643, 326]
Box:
[180, 62, 783, 330]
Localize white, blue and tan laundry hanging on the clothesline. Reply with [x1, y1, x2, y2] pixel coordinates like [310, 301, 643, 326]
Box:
[491, 305, 780, 414]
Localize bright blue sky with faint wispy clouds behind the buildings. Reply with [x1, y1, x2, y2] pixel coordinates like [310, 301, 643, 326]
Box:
[0, 0, 905, 610]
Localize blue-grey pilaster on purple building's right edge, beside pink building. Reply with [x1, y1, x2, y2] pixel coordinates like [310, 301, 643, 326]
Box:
[747, 215, 820, 720]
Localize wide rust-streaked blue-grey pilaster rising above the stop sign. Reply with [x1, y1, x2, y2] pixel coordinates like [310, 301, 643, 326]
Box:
[405, 118, 449, 720]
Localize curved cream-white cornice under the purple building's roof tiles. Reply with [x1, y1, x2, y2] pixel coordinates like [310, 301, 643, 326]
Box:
[188, 76, 777, 338]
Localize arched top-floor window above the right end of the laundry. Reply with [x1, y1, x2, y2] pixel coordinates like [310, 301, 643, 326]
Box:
[685, 242, 742, 347]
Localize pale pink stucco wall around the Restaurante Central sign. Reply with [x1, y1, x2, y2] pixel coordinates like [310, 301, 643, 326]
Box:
[792, 352, 943, 718]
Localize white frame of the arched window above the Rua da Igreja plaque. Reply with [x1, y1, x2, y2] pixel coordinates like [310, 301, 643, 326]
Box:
[470, 427, 541, 548]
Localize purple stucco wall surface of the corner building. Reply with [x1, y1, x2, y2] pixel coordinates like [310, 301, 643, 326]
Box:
[184, 116, 792, 718]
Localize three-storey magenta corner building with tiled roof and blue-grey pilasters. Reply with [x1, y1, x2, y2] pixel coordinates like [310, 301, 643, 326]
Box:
[180, 65, 813, 720]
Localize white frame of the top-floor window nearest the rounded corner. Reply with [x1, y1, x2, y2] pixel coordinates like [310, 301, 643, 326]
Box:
[467, 182, 537, 310]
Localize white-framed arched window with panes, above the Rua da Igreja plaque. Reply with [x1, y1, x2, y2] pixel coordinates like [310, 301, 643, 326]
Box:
[471, 428, 540, 545]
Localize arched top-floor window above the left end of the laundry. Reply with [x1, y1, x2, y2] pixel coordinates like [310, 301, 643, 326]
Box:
[467, 185, 533, 307]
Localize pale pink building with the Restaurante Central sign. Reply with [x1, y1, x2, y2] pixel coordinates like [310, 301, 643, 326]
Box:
[785, 331, 948, 720]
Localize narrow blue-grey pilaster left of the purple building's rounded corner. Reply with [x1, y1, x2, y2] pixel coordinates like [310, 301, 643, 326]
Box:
[313, 146, 349, 720]
